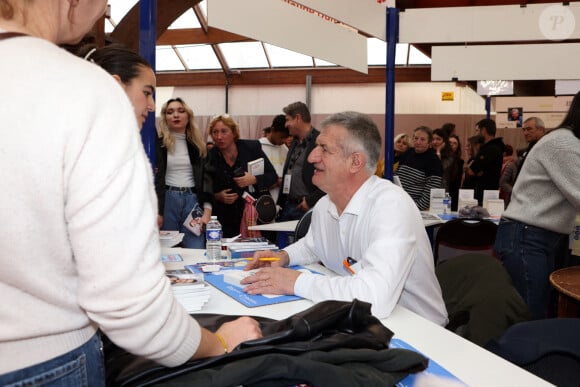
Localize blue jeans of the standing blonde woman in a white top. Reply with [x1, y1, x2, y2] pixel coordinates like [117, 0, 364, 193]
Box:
[161, 190, 205, 249]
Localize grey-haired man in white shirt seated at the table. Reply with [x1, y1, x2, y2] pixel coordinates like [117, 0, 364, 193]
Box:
[242, 112, 447, 325]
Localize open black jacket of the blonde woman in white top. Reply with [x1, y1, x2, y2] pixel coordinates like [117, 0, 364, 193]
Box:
[155, 137, 214, 215]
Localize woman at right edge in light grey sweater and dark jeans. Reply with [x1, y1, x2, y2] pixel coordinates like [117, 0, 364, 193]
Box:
[495, 93, 580, 319]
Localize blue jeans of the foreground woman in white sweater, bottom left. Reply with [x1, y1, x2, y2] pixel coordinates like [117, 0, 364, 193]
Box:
[0, 333, 105, 387]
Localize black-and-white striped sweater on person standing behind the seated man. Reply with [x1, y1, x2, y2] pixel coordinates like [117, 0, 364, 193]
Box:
[396, 148, 443, 211]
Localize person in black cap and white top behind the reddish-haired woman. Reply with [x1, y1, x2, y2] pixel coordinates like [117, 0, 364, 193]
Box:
[258, 114, 290, 202]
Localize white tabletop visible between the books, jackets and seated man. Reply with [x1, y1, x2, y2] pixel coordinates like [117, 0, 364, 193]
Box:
[162, 248, 551, 387]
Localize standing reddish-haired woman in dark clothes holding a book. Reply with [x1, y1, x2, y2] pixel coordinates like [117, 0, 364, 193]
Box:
[208, 114, 278, 238]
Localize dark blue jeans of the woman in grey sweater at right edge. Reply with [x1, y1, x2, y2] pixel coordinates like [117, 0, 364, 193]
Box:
[494, 218, 568, 319]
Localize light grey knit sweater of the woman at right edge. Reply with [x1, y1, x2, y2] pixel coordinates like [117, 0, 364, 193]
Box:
[503, 129, 580, 234]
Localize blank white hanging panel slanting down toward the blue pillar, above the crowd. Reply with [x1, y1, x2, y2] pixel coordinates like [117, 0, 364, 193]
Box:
[207, 0, 368, 74]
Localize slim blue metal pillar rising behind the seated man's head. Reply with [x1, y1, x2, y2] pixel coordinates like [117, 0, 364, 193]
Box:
[384, 7, 399, 180]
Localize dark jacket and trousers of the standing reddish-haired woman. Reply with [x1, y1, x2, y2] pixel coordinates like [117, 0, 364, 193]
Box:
[209, 140, 278, 238]
